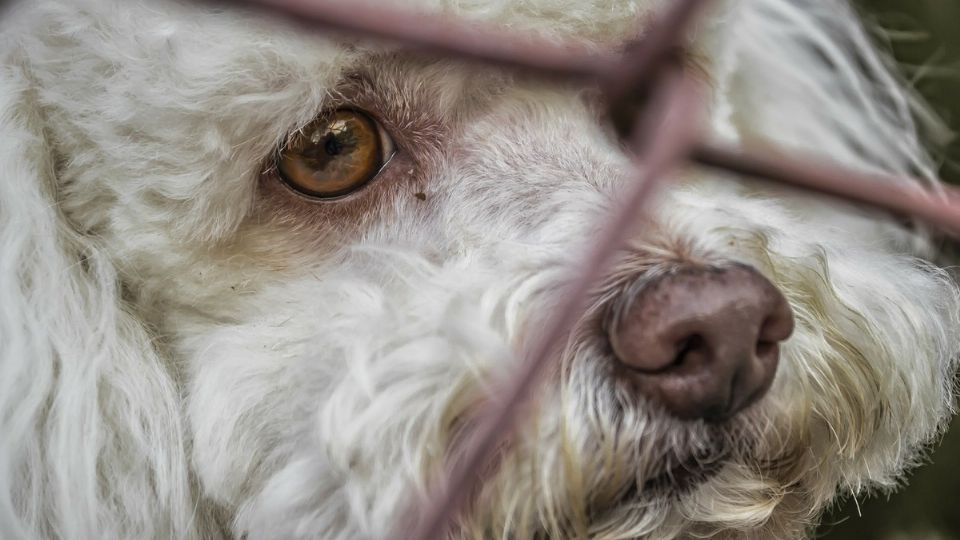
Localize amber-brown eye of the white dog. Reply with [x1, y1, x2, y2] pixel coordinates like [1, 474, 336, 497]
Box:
[277, 109, 394, 199]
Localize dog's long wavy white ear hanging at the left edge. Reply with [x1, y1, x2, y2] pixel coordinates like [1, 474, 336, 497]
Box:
[0, 51, 191, 538]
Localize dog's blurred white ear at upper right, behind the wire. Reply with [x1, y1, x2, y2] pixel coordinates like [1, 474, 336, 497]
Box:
[719, 0, 945, 184]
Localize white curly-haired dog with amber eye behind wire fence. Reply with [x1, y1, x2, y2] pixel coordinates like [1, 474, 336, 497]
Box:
[0, 0, 960, 539]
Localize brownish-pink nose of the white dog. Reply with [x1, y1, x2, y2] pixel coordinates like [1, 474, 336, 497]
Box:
[608, 265, 793, 421]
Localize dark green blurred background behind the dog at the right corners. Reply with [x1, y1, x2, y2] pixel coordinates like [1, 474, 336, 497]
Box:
[816, 0, 960, 540]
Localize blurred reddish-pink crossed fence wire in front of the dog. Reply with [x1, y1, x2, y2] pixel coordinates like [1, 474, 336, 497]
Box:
[214, 0, 960, 540]
